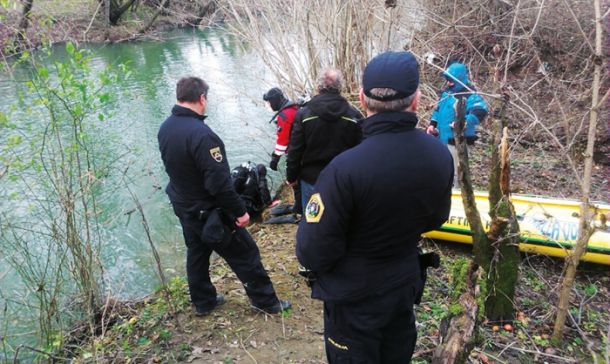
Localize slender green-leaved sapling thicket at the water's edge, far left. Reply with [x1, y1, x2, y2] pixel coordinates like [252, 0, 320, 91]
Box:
[0, 43, 128, 362]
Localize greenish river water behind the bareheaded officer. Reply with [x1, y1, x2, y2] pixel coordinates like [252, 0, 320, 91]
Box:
[0, 29, 281, 343]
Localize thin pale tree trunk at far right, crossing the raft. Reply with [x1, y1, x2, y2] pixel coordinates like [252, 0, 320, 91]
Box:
[553, 0, 603, 343]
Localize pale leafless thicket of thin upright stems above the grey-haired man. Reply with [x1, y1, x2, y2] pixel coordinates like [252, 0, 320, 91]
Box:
[220, 0, 418, 96]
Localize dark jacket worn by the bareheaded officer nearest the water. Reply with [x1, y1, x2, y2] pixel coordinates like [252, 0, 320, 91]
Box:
[157, 105, 246, 218]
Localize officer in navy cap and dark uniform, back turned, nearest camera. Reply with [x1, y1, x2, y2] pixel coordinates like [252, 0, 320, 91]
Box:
[296, 52, 453, 363]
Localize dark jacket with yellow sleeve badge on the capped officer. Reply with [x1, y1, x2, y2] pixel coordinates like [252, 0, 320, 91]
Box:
[296, 112, 453, 302]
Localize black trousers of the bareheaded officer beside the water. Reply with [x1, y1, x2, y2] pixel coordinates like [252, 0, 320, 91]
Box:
[174, 207, 278, 309]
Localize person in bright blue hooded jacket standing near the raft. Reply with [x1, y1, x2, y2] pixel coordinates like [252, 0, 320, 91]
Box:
[427, 62, 488, 186]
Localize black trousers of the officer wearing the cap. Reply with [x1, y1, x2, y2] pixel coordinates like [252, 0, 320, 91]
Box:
[324, 277, 421, 364]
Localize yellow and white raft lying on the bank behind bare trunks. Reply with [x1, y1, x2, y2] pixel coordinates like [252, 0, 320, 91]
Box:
[424, 190, 610, 265]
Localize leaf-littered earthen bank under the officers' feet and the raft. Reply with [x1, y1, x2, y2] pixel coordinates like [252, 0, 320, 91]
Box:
[61, 186, 610, 364]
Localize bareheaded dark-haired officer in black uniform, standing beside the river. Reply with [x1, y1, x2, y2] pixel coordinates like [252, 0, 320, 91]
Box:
[157, 77, 290, 315]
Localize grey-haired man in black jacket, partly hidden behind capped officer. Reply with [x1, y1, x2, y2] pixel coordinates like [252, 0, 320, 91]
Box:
[286, 68, 362, 210]
